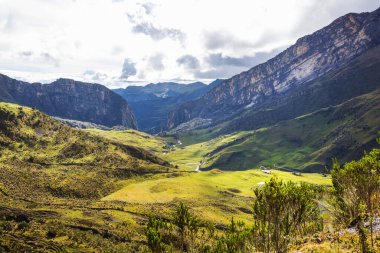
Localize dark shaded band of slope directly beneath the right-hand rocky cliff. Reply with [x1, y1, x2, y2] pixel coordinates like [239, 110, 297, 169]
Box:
[221, 43, 380, 133]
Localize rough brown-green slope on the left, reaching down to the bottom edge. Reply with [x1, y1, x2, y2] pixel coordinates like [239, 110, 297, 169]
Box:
[0, 103, 171, 252]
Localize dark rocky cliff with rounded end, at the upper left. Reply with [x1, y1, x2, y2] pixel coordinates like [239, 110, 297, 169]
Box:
[0, 75, 137, 129]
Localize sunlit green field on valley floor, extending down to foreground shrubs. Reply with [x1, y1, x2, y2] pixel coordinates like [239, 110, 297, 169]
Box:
[102, 169, 331, 223]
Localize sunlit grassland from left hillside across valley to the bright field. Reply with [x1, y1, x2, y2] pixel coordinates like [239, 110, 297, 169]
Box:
[0, 104, 350, 252]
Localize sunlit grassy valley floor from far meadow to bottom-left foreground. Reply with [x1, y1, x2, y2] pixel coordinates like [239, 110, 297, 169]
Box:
[0, 117, 378, 252]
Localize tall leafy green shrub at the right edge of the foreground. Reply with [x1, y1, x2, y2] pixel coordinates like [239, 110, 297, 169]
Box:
[331, 143, 380, 252]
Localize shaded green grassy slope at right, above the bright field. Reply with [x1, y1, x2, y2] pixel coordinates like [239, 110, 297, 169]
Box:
[176, 87, 380, 171]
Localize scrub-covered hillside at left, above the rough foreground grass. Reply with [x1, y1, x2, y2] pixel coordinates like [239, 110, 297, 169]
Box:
[0, 103, 169, 201]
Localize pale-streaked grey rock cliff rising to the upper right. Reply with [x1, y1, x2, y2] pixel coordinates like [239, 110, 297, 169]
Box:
[167, 6, 380, 128]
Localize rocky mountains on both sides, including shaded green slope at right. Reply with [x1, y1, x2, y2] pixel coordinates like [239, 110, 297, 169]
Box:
[0, 6, 380, 171]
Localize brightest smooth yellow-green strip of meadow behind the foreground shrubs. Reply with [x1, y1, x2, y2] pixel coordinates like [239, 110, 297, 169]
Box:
[102, 169, 331, 203]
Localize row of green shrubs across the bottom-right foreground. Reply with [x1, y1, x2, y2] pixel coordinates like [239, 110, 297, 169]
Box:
[140, 160, 380, 252]
